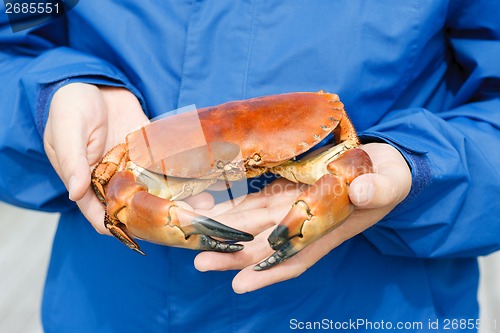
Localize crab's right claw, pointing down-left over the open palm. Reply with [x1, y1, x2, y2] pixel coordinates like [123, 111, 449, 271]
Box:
[254, 148, 372, 271]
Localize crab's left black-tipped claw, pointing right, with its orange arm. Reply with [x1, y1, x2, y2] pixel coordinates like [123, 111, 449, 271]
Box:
[105, 170, 253, 254]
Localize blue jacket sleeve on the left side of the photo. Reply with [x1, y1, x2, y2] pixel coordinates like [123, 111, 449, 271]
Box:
[0, 14, 141, 211]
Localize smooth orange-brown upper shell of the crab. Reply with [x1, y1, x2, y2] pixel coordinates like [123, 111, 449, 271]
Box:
[127, 91, 350, 178]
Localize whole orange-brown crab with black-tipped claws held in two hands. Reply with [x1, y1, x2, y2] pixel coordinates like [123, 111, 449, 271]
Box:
[91, 91, 372, 270]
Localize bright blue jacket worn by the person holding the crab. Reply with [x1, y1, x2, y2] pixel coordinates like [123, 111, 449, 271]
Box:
[0, 0, 500, 332]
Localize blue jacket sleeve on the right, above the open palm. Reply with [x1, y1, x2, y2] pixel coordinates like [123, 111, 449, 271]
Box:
[362, 1, 500, 258]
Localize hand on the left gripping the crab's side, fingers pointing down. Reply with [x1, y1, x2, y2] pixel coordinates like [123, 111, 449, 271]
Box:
[43, 83, 148, 234]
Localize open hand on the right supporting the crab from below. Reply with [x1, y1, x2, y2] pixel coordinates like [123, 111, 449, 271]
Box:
[195, 143, 411, 293]
